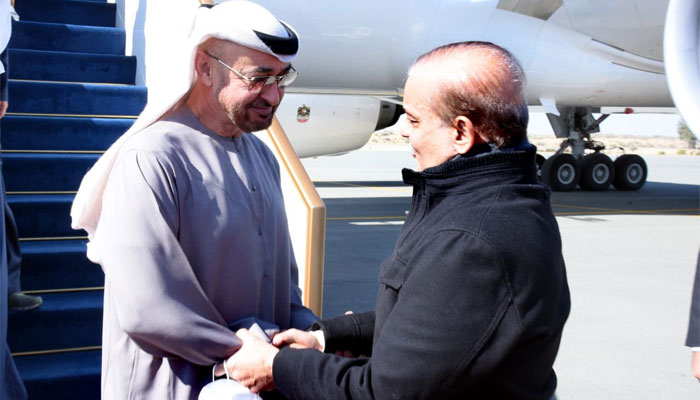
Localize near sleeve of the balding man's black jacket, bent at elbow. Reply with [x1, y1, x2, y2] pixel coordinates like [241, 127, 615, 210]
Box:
[273, 230, 518, 399]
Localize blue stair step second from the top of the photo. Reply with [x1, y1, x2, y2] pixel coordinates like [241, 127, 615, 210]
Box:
[8, 21, 126, 55]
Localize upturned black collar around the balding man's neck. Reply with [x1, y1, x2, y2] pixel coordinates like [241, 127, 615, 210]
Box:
[402, 140, 537, 193]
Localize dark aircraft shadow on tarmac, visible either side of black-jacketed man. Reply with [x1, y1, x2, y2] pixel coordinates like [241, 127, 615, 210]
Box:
[319, 182, 700, 317]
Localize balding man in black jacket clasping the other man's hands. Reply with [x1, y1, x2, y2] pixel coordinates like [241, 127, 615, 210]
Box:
[228, 42, 570, 400]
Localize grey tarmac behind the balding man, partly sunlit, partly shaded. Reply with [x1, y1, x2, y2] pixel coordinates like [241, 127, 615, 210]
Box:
[304, 150, 700, 400]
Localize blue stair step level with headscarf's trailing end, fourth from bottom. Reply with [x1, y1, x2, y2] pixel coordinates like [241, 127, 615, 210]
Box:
[6, 194, 87, 240]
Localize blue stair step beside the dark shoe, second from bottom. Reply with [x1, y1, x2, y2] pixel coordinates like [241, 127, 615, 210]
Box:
[7, 290, 104, 353]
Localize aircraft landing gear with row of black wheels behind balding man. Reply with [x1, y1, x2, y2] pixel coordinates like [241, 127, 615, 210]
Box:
[537, 107, 647, 191]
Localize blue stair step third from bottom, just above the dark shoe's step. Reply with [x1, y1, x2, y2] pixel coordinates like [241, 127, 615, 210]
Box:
[20, 240, 104, 290]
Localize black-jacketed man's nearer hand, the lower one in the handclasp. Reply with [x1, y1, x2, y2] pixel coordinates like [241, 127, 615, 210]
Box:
[226, 329, 279, 393]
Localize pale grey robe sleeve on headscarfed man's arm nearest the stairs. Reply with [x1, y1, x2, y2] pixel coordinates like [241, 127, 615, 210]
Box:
[98, 151, 240, 365]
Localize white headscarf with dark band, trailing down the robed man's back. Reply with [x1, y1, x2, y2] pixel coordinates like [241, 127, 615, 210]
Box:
[71, 0, 299, 262]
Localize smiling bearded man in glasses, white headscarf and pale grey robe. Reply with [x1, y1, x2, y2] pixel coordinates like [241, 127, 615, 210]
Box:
[72, 1, 316, 399]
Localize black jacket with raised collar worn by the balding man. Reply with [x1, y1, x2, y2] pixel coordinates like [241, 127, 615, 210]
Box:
[273, 144, 570, 400]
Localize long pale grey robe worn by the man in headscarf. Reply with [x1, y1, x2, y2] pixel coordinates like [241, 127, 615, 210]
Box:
[94, 106, 315, 399]
